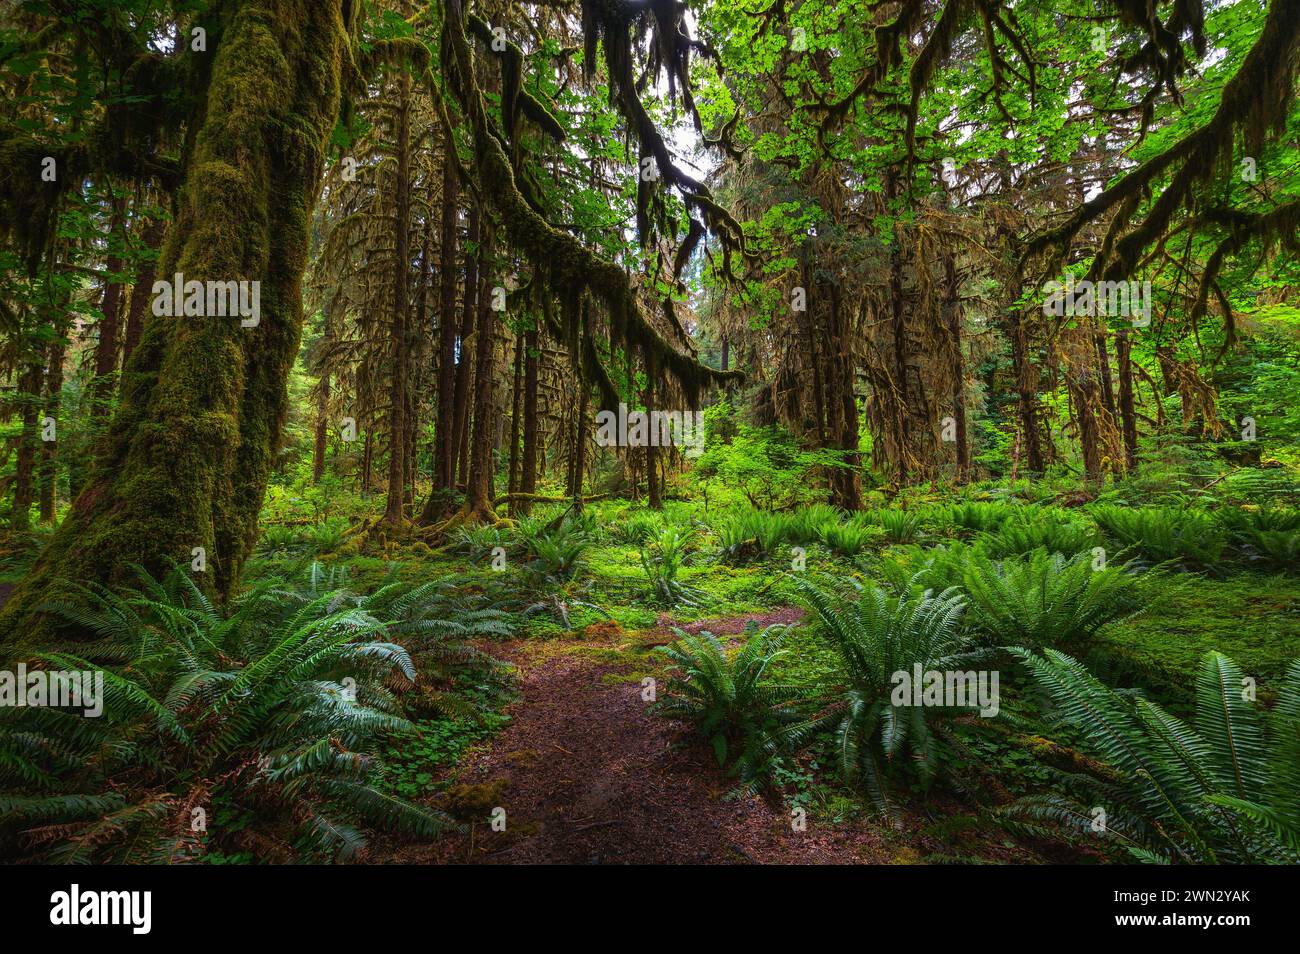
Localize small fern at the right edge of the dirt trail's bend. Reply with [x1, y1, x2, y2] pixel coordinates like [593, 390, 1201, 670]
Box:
[654, 626, 806, 781]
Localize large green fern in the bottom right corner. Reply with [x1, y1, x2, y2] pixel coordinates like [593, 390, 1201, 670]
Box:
[1005, 650, 1300, 864]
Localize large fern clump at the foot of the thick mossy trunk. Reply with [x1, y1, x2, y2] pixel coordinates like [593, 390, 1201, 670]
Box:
[0, 569, 443, 863]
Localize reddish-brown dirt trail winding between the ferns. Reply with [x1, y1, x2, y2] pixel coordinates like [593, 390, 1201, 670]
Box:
[399, 610, 898, 864]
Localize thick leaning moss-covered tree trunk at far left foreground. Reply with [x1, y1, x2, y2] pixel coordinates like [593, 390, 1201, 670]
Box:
[0, 0, 354, 649]
